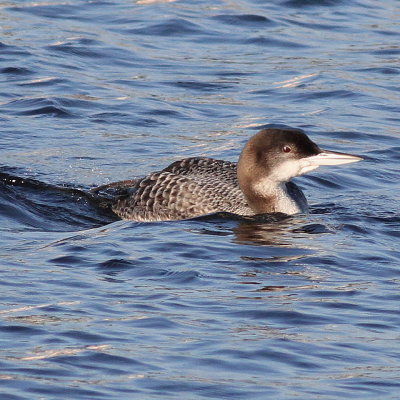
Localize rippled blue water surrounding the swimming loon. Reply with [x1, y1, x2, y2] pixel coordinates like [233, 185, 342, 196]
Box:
[0, 0, 400, 400]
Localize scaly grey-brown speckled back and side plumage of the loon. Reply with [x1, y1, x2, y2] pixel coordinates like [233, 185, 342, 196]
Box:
[112, 158, 254, 221]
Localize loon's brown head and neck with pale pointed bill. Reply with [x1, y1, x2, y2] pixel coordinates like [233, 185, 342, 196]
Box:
[237, 128, 361, 213]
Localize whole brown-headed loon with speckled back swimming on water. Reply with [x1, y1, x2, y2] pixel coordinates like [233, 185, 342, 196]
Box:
[92, 128, 362, 222]
